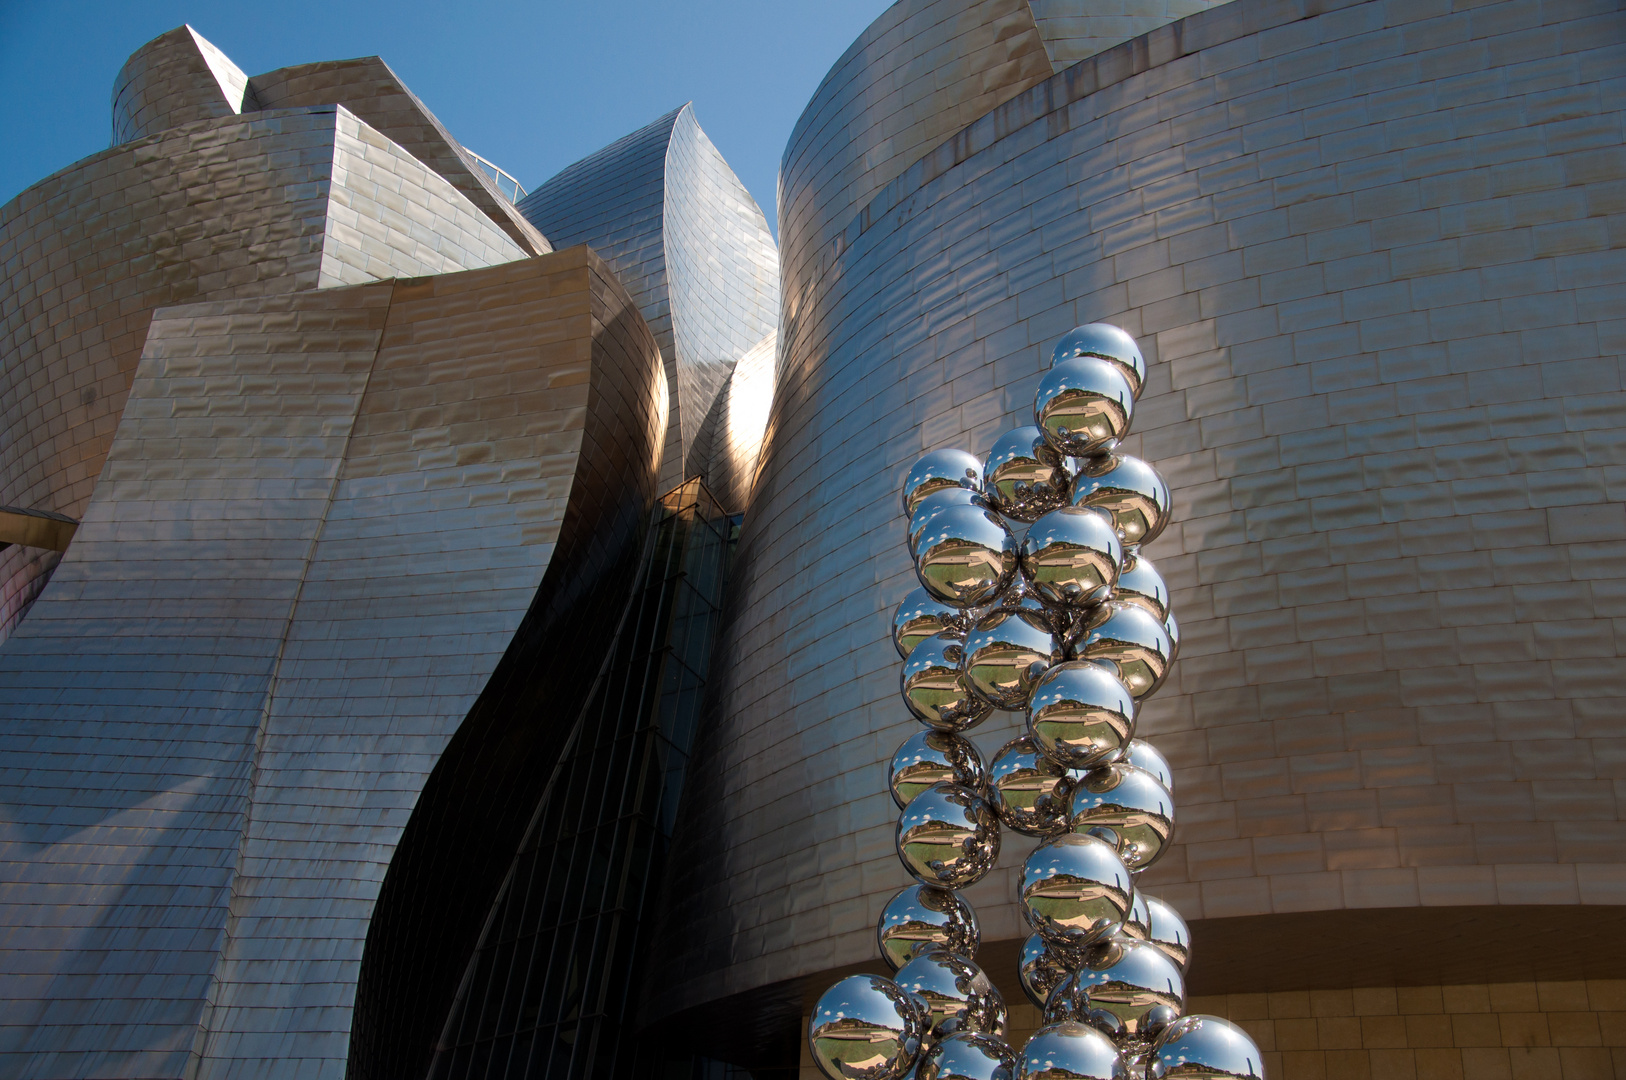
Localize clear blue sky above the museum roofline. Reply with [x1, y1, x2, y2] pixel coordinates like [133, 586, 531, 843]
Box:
[0, 0, 889, 233]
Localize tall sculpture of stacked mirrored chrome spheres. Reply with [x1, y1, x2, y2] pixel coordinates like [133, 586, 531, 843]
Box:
[808, 324, 1263, 1080]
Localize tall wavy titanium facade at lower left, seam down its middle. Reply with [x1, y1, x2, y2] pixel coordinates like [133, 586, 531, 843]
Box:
[0, 249, 665, 1077]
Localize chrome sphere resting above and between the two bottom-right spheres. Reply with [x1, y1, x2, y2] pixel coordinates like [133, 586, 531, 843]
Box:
[1044, 934, 1185, 1046]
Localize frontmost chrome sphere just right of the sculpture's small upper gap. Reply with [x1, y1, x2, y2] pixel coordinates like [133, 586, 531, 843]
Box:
[1028, 660, 1137, 769]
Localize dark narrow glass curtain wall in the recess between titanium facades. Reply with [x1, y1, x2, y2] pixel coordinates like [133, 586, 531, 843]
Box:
[429, 480, 740, 1080]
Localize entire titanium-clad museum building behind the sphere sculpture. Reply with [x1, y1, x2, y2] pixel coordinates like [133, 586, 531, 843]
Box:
[0, 0, 1626, 1080]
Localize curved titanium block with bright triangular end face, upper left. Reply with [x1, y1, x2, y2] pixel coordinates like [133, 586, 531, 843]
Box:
[0, 99, 524, 638]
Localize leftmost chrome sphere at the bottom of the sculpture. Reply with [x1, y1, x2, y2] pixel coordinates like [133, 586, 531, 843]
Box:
[808, 974, 925, 1080]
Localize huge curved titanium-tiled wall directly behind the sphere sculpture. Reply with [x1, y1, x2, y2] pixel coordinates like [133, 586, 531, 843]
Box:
[657, 0, 1626, 1040]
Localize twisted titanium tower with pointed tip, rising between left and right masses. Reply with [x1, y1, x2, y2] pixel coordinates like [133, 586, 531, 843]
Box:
[520, 106, 779, 509]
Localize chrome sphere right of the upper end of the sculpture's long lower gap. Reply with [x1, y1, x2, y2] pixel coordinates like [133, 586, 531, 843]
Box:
[1018, 833, 1135, 950]
